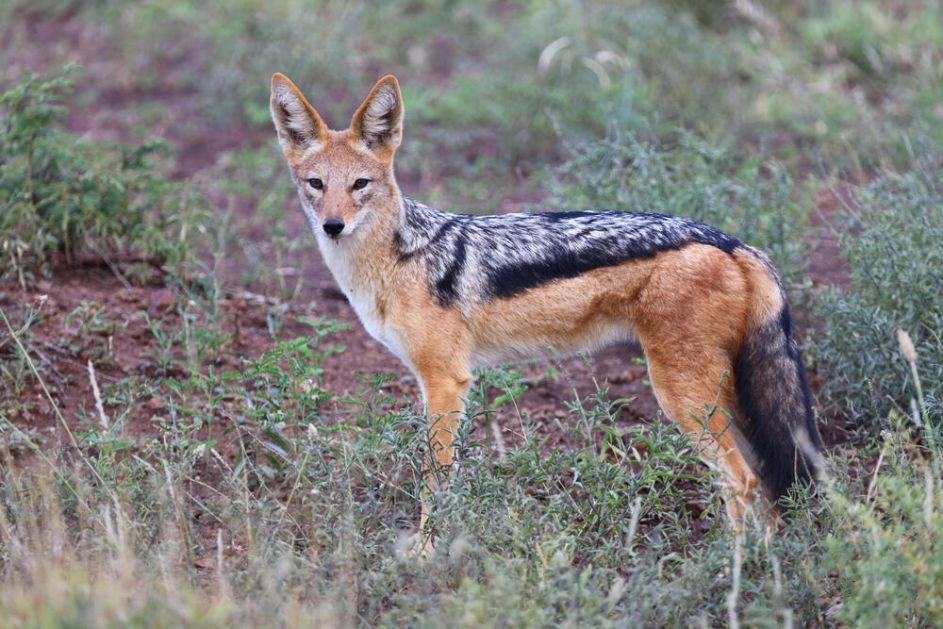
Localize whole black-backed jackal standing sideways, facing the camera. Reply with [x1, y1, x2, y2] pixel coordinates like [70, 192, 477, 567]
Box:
[271, 74, 821, 527]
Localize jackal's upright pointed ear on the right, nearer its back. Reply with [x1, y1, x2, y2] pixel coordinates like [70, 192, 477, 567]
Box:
[350, 74, 403, 161]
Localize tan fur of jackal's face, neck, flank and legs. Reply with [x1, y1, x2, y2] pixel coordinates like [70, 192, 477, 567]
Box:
[273, 75, 782, 544]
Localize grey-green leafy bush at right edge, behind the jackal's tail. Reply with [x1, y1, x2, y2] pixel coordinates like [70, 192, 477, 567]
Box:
[814, 160, 943, 428]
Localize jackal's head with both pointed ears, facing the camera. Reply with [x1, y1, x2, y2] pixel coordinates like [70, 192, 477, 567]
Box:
[271, 74, 403, 241]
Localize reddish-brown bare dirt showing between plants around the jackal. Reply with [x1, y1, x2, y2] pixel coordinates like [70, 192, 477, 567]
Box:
[0, 9, 844, 474]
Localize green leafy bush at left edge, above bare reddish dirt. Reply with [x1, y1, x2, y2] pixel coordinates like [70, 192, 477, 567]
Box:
[0, 71, 204, 284]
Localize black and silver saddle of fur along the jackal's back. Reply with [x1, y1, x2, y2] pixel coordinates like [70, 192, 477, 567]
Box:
[396, 199, 741, 306]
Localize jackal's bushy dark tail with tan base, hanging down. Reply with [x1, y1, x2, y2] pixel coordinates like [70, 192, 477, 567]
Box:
[733, 249, 821, 500]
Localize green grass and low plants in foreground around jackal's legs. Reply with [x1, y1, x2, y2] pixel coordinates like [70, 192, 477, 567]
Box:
[0, 304, 943, 626]
